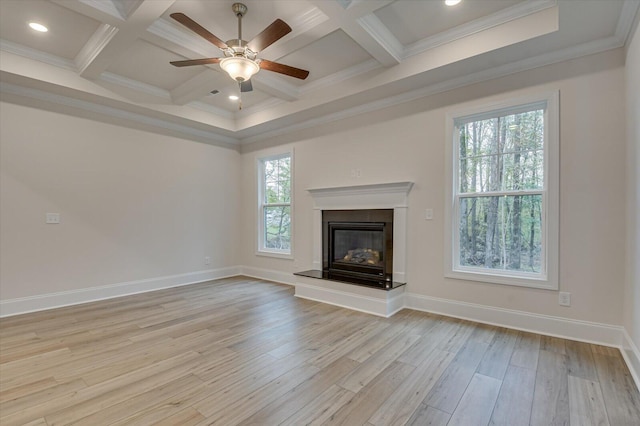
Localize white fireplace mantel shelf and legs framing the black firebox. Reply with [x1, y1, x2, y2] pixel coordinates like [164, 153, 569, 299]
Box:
[307, 182, 413, 283]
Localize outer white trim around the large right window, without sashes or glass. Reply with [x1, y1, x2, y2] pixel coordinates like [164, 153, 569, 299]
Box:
[444, 91, 560, 290]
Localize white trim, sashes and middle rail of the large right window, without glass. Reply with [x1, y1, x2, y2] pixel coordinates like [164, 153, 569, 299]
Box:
[445, 91, 559, 290]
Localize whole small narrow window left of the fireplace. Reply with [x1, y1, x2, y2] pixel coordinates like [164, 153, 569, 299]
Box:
[258, 152, 292, 257]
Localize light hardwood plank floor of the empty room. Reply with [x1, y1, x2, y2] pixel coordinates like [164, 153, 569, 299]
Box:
[0, 278, 640, 426]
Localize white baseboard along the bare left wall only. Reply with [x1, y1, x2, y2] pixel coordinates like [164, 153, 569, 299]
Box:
[0, 266, 240, 317]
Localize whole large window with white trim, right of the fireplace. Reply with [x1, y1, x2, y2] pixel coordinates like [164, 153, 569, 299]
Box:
[446, 94, 559, 289]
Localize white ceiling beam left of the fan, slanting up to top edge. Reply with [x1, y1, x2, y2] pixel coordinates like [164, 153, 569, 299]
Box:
[75, 0, 175, 79]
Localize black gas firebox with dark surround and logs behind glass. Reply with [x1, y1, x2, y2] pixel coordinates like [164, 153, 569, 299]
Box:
[322, 209, 393, 285]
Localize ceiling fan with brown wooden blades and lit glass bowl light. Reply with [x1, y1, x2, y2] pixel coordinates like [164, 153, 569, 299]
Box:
[170, 3, 309, 92]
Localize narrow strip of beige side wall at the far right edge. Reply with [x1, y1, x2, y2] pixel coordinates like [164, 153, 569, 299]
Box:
[624, 20, 640, 366]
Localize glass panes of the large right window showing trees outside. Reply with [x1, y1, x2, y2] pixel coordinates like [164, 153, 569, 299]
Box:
[456, 107, 545, 273]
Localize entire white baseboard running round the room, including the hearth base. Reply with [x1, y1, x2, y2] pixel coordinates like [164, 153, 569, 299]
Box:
[0, 266, 640, 388]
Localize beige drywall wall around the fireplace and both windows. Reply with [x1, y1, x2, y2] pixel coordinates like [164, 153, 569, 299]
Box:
[241, 50, 625, 325]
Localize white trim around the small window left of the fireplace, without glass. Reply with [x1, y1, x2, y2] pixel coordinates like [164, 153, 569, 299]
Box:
[255, 149, 295, 259]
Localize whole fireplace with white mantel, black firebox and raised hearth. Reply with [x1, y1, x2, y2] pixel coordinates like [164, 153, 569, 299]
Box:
[294, 182, 413, 317]
